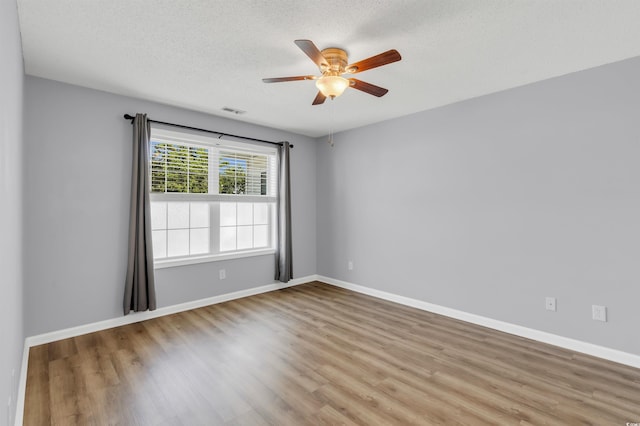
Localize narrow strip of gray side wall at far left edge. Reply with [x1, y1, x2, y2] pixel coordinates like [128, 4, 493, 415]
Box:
[0, 0, 24, 424]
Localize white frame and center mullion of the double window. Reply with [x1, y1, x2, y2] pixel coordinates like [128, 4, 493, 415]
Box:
[150, 126, 278, 269]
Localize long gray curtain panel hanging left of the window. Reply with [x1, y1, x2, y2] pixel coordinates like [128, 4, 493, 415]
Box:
[124, 114, 156, 315]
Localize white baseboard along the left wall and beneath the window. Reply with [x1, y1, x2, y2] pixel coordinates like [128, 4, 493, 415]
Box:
[15, 275, 318, 426]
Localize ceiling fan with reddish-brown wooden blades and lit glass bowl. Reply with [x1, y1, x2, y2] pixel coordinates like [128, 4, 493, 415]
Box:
[262, 40, 402, 105]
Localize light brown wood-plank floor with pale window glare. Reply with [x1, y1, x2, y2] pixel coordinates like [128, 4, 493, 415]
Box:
[24, 282, 640, 426]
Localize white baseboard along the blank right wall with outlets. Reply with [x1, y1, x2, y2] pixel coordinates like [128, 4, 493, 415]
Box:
[316, 275, 640, 368]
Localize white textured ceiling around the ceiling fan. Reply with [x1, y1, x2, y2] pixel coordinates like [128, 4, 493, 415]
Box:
[18, 0, 640, 136]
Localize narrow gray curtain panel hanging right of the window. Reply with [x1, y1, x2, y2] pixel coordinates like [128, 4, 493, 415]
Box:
[276, 142, 293, 283]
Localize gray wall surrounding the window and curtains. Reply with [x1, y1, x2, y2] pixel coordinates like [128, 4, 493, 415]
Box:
[25, 77, 316, 335]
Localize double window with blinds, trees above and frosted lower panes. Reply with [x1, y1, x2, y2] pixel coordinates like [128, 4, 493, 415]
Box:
[149, 128, 277, 265]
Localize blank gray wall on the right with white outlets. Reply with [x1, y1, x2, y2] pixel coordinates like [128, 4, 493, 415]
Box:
[317, 58, 640, 355]
